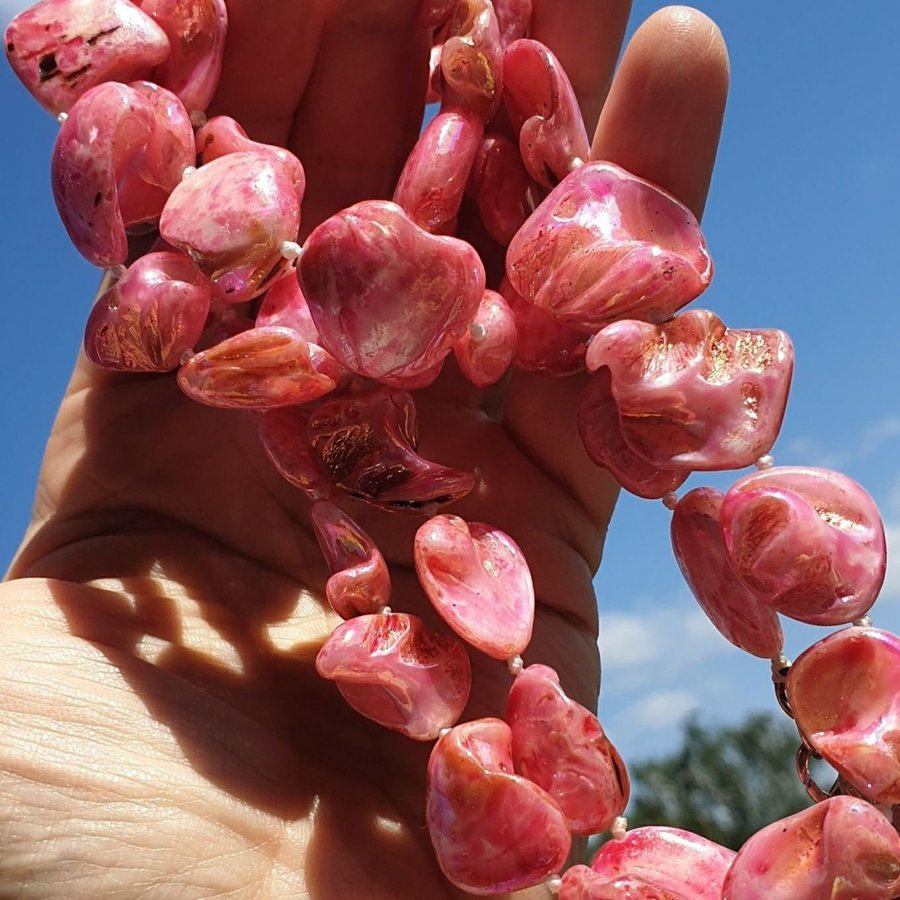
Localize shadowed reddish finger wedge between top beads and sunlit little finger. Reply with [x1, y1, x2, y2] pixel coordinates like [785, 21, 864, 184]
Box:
[531, 0, 631, 134]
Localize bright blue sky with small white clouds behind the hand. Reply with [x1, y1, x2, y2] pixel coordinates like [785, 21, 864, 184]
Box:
[0, 0, 900, 759]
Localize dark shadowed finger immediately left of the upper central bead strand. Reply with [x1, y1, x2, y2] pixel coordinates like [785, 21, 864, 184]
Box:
[290, 0, 430, 230]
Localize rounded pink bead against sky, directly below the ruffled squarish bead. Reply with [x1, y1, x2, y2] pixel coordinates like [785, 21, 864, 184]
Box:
[720, 466, 887, 625]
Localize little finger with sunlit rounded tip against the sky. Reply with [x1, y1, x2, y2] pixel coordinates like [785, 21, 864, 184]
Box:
[591, 6, 728, 218]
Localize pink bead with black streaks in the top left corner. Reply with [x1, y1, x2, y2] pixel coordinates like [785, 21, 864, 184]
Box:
[3, 0, 169, 115]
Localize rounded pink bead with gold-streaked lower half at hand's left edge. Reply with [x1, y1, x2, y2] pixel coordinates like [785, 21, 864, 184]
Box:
[84, 253, 209, 372]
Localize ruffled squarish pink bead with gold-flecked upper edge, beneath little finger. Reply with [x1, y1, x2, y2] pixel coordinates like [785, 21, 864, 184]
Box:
[586, 309, 794, 471]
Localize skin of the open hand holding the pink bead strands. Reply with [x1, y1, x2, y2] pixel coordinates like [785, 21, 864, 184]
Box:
[0, 0, 727, 900]
